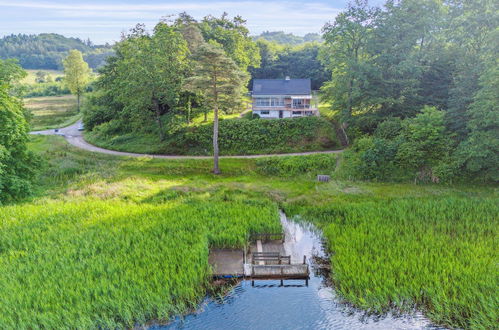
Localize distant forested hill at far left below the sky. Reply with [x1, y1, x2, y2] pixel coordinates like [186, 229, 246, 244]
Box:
[0, 33, 113, 70]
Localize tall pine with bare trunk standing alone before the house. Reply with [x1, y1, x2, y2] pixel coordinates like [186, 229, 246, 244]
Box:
[186, 43, 248, 174]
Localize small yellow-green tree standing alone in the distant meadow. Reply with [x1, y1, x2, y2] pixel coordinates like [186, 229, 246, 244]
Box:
[63, 49, 91, 112]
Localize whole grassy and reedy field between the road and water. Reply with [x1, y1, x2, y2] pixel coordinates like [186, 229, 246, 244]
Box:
[0, 136, 499, 328]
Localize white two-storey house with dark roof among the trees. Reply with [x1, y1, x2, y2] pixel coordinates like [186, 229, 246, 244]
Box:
[251, 77, 319, 118]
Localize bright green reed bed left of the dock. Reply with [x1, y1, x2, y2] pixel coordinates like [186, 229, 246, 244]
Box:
[0, 194, 280, 329]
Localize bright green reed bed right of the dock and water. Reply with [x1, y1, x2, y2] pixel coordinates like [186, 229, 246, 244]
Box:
[289, 197, 499, 329]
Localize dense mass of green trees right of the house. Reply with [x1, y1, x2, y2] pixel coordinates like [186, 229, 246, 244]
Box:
[320, 0, 499, 181]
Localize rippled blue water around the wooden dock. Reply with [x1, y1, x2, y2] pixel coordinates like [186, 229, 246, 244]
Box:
[151, 214, 440, 330]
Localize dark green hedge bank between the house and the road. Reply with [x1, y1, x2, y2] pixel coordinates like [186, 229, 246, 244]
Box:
[86, 117, 339, 155]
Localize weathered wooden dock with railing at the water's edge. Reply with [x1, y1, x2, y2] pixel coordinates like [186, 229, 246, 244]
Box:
[209, 234, 310, 285]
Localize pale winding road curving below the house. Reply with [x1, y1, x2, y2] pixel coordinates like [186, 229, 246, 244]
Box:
[30, 121, 343, 159]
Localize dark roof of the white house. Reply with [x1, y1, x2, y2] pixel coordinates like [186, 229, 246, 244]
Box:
[253, 79, 312, 95]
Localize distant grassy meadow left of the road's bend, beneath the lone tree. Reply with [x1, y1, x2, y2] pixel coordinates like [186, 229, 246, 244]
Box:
[24, 95, 80, 131]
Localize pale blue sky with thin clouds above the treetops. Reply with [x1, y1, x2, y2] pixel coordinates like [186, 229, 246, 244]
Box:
[0, 0, 382, 44]
